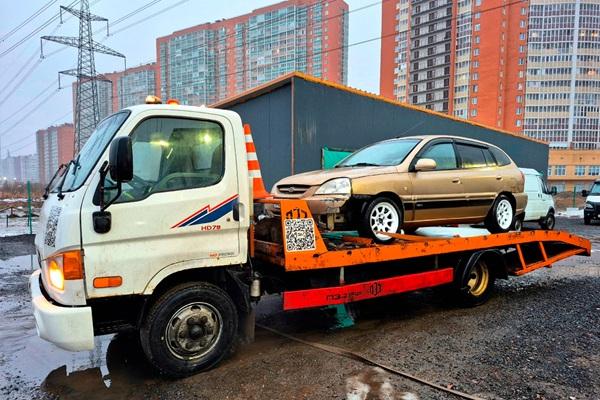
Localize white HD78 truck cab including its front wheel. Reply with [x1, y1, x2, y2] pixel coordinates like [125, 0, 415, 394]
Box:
[30, 104, 252, 375]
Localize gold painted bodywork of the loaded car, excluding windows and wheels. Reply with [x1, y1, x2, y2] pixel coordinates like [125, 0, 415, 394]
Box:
[272, 135, 527, 229]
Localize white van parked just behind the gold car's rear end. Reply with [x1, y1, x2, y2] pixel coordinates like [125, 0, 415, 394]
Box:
[515, 168, 556, 230]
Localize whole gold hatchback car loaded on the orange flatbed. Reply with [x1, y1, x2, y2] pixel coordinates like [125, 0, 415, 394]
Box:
[272, 136, 527, 242]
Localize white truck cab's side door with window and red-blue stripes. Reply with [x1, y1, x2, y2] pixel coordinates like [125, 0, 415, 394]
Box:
[81, 111, 244, 297]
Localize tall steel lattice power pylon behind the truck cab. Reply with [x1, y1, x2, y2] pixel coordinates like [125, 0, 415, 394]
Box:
[41, 0, 125, 154]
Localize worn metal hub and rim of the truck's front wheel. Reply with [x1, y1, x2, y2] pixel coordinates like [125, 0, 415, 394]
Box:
[165, 303, 223, 360]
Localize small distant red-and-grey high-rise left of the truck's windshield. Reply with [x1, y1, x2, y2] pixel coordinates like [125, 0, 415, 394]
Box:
[36, 124, 75, 184]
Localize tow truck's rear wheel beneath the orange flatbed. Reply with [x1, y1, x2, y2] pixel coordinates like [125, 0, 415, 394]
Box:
[458, 258, 495, 307]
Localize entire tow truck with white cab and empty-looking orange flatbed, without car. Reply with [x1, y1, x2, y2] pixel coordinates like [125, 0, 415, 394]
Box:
[30, 96, 591, 377]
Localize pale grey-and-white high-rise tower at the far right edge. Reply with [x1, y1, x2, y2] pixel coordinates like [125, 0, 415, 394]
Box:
[524, 0, 600, 149]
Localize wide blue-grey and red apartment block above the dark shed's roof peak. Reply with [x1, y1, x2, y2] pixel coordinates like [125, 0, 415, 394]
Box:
[156, 0, 348, 105]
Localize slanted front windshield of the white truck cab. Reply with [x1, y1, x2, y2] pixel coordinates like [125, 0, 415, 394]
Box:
[59, 111, 129, 192]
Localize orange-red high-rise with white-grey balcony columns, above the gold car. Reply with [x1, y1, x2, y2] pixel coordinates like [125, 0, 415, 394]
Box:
[380, 0, 528, 131]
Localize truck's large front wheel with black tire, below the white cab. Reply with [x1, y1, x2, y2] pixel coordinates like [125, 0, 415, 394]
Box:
[140, 282, 238, 378]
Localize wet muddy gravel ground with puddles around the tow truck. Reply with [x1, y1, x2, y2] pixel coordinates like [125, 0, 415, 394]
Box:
[0, 218, 600, 400]
